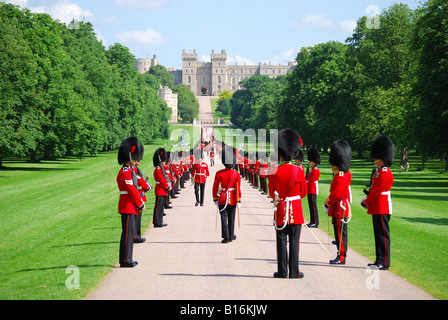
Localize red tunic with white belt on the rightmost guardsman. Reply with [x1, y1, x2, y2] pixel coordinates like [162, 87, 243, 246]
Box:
[363, 167, 394, 214]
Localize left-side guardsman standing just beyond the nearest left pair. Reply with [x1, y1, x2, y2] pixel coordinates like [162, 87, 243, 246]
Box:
[153, 148, 171, 228]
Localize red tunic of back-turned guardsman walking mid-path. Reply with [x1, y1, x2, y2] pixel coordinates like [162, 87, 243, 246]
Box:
[213, 169, 241, 206]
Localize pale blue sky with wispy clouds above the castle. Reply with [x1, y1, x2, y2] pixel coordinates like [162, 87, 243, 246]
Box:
[6, 0, 419, 68]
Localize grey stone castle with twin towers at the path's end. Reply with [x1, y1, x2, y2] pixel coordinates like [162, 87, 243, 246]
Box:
[136, 49, 297, 96]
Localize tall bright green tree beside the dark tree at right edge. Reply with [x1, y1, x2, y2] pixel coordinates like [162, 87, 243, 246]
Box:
[347, 4, 416, 156]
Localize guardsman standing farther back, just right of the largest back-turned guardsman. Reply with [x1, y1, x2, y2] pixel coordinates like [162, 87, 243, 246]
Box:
[306, 148, 321, 228]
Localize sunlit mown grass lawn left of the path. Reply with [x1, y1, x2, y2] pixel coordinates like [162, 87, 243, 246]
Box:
[0, 142, 163, 300]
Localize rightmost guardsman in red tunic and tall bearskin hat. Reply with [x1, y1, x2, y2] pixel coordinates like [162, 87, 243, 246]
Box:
[361, 136, 395, 270]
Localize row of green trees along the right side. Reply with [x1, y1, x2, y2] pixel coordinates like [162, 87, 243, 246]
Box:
[229, 0, 448, 169]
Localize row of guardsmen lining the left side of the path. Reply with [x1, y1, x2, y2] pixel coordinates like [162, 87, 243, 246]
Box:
[117, 137, 193, 268]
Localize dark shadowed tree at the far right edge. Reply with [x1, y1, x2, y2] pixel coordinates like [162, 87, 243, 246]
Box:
[412, 0, 448, 171]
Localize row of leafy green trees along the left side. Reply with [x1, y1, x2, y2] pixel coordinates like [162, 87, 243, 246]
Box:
[0, 2, 171, 166]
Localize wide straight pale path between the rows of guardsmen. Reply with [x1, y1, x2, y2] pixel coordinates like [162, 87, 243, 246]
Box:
[87, 155, 432, 300]
